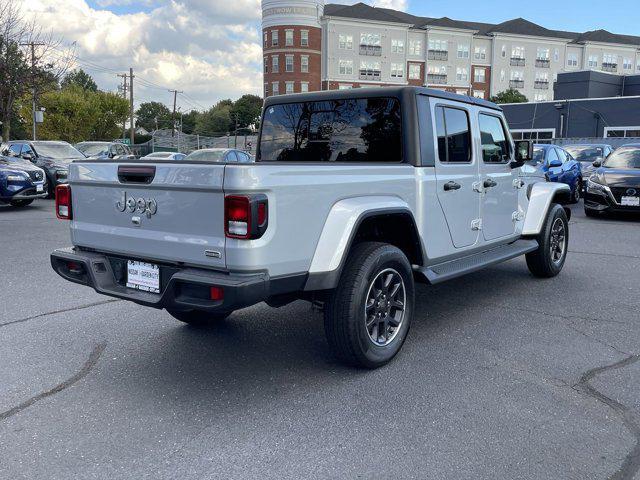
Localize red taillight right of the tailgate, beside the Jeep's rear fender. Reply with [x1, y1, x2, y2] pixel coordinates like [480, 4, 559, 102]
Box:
[224, 194, 269, 240]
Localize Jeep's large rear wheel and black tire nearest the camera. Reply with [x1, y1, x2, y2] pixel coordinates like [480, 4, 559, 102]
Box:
[324, 242, 414, 369]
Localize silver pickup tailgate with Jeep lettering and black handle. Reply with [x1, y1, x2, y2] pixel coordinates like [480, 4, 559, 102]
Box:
[69, 162, 225, 268]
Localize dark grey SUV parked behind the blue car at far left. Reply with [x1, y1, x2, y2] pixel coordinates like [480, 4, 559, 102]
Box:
[6, 140, 87, 197]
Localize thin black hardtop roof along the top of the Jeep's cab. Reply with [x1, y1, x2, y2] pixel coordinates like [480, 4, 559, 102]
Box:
[264, 86, 502, 111]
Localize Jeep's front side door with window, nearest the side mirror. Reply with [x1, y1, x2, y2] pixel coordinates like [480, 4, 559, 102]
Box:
[478, 113, 520, 241]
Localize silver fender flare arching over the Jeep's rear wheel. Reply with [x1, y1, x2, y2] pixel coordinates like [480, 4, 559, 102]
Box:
[305, 196, 418, 291]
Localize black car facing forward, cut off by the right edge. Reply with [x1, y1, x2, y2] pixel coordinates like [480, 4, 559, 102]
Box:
[584, 144, 640, 217]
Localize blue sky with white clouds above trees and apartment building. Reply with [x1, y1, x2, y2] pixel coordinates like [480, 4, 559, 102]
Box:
[18, 0, 640, 111]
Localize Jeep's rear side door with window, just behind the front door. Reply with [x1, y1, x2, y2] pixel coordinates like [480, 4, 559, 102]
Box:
[434, 101, 482, 248]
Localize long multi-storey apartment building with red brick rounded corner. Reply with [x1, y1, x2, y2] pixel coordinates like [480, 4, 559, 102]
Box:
[262, 0, 640, 101]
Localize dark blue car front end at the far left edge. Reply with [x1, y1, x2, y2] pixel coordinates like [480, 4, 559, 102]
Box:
[0, 156, 47, 207]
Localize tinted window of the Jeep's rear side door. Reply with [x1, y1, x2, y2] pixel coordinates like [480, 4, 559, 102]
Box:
[436, 107, 471, 163]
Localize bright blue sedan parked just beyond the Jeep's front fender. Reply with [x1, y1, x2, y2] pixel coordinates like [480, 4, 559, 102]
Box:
[531, 144, 583, 203]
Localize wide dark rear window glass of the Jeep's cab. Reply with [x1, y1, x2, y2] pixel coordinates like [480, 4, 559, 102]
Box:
[257, 98, 402, 163]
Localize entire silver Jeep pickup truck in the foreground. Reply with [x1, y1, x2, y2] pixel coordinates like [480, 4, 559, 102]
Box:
[51, 87, 570, 368]
